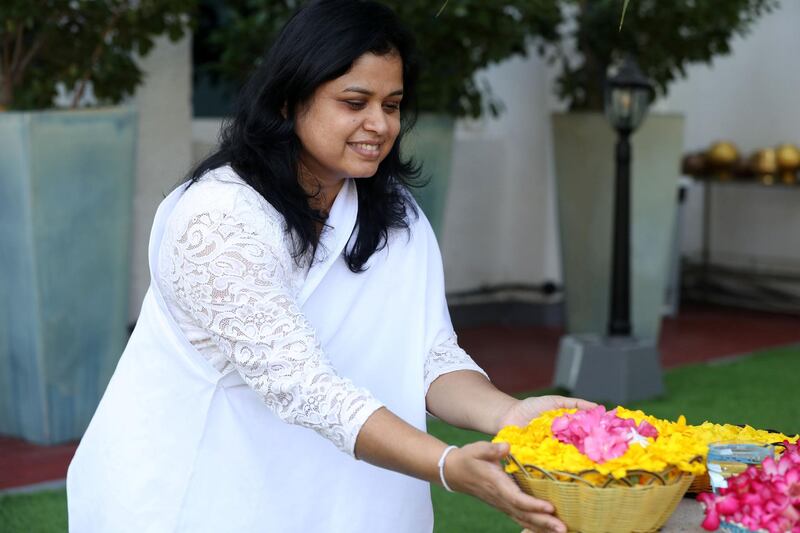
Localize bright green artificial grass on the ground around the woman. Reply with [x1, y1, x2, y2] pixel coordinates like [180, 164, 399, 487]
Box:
[0, 347, 800, 533]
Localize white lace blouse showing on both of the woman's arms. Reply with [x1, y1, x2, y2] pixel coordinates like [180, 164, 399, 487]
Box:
[153, 168, 485, 455]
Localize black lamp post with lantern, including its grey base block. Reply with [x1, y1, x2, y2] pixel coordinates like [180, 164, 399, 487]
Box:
[555, 58, 664, 404]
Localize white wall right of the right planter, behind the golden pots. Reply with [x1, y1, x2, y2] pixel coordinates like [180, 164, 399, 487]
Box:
[659, 0, 800, 271]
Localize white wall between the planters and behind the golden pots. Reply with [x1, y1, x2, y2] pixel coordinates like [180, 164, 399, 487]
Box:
[442, 0, 800, 291]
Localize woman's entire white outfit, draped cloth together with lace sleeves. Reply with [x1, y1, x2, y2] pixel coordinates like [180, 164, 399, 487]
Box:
[67, 168, 488, 533]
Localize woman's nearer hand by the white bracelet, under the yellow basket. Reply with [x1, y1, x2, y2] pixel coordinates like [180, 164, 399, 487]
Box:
[444, 442, 567, 533]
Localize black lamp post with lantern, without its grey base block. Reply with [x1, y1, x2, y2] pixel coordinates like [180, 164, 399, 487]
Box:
[605, 58, 655, 337]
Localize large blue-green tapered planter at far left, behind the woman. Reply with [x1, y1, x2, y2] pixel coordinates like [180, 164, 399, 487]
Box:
[0, 108, 136, 444]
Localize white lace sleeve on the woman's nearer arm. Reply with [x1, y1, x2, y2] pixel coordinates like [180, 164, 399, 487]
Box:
[162, 195, 381, 455]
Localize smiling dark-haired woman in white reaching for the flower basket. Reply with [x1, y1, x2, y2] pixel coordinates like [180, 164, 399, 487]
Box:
[67, 0, 590, 533]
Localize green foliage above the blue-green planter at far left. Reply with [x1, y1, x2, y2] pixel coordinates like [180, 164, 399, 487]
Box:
[0, 0, 196, 109]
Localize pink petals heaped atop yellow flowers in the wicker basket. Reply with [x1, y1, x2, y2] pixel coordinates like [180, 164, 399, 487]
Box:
[550, 405, 658, 464]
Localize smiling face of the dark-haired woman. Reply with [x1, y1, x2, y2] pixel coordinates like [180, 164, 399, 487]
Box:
[295, 53, 403, 187]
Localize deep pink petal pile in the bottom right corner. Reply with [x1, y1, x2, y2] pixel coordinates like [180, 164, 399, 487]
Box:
[697, 442, 800, 533]
